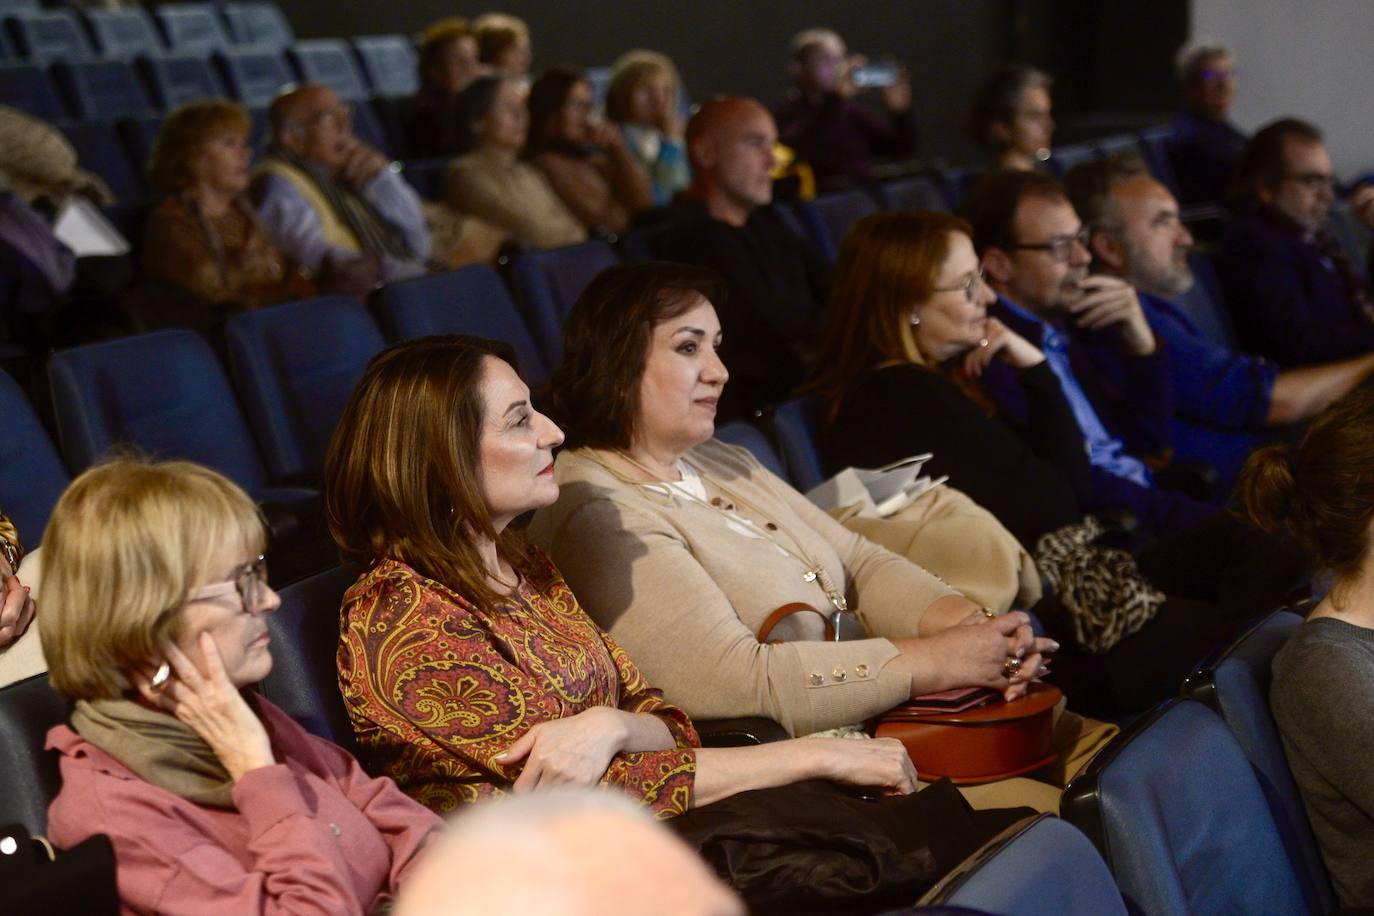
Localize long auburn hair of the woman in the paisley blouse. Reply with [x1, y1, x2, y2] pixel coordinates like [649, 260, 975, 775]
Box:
[324, 334, 529, 607]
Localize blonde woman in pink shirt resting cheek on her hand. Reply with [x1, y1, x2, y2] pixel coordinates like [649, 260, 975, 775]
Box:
[43, 460, 440, 916]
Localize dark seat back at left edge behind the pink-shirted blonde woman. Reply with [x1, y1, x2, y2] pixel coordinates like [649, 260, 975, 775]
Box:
[0, 674, 67, 835]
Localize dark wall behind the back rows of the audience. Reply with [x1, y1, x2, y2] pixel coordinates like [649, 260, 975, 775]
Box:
[282, 0, 1187, 161]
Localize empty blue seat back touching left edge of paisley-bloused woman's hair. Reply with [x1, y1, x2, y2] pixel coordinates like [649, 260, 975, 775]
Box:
[225, 295, 386, 483]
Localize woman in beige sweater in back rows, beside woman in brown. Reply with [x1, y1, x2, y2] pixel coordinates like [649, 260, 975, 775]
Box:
[444, 77, 587, 249]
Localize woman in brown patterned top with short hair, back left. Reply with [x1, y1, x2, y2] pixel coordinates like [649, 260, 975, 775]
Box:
[142, 100, 316, 309]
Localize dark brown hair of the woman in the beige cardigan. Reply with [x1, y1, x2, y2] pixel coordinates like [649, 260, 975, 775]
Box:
[548, 261, 727, 449]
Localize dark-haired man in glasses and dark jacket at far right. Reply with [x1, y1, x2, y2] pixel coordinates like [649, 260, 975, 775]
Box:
[1215, 118, 1374, 368]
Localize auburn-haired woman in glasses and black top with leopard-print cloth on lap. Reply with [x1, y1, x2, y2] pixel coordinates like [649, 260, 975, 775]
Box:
[812, 211, 1253, 715]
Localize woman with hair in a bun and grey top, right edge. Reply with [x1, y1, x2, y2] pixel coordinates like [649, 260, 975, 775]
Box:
[1239, 387, 1374, 909]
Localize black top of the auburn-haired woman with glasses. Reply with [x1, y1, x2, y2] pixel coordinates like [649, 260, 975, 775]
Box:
[822, 363, 1091, 548]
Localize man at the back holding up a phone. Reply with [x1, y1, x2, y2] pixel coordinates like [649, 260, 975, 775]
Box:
[774, 29, 916, 183]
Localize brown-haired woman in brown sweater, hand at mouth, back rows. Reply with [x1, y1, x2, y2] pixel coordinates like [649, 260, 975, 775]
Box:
[525, 70, 654, 233]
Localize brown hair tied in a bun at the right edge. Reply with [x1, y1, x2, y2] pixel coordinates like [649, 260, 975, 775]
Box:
[1237, 386, 1374, 587]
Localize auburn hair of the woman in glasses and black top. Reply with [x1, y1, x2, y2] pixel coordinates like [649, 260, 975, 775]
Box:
[808, 210, 973, 420]
